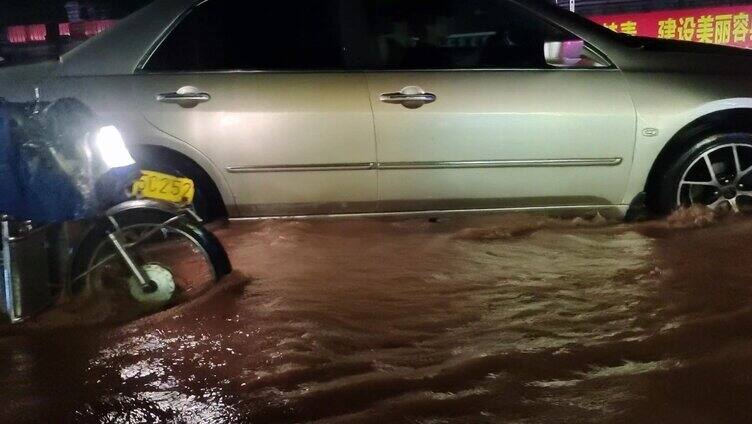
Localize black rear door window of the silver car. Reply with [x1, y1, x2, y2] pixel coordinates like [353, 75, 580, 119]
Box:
[144, 0, 344, 72]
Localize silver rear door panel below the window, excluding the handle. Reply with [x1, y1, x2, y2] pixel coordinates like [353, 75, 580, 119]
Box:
[132, 72, 377, 214]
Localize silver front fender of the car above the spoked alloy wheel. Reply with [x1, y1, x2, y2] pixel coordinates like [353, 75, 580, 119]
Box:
[610, 39, 752, 203]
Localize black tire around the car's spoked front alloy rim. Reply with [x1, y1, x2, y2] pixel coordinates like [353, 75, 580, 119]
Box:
[648, 132, 752, 215]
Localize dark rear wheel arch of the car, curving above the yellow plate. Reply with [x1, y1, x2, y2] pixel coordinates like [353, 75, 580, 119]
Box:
[130, 144, 232, 218]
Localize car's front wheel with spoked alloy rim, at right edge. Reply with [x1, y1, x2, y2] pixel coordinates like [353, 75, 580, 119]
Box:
[653, 133, 752, 213]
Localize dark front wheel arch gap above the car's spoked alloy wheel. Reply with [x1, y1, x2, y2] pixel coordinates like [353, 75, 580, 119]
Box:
[644, 108, 752, 202]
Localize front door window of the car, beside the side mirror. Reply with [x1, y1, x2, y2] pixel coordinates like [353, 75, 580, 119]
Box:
[348, 0, 602, 70]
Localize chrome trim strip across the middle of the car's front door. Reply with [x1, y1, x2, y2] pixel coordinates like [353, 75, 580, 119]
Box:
[377, 158, 622, 170]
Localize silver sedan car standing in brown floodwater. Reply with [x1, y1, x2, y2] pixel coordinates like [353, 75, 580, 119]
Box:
[0, 0, 752, 217]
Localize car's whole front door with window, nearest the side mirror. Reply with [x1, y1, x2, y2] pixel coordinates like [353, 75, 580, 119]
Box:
[351, 0, 635, 211]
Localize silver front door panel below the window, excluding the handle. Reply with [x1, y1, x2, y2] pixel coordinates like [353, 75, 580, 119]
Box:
[368, 69, 635, 207]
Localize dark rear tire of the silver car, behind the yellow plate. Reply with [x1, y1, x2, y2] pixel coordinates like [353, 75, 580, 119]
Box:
[133, 147, 227, 222]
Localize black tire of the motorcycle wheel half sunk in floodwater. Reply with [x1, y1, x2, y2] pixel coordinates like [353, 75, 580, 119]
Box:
[70, 209, 232, 294]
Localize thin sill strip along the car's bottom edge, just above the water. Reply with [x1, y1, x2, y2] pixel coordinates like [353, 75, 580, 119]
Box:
[229, 205, 629, 222]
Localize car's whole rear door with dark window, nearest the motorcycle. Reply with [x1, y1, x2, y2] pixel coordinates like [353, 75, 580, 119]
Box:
[134, 0, 377, 216]
